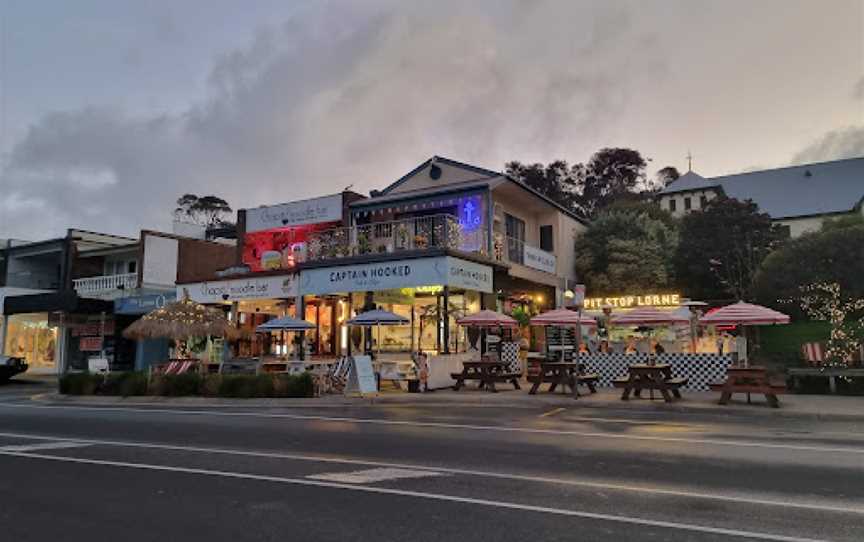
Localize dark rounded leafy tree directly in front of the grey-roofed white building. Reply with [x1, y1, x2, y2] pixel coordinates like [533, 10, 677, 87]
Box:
[674, 196, 782, 300]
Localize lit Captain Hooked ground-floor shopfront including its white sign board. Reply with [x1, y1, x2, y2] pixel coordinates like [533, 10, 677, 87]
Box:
[300, 255, 493, 356]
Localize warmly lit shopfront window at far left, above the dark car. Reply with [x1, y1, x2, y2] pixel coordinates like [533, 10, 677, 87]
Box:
[3, 312, 58, 369]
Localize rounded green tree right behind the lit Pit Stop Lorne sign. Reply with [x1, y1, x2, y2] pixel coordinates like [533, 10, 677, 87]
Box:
[576, 204, 678, 296]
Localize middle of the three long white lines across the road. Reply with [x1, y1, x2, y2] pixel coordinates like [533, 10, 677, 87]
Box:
[0, 433, 864, 515]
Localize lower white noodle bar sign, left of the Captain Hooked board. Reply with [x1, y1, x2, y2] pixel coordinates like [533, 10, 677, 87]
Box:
[177, 274, 298, 304]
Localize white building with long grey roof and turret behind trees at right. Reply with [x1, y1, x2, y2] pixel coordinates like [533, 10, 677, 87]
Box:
[658, 157, 864, 237]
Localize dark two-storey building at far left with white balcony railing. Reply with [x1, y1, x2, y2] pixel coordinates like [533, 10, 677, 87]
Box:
[0, 229, 235, 373]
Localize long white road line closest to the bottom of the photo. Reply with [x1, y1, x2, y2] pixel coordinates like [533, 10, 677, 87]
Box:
[0, 451, 828, 542]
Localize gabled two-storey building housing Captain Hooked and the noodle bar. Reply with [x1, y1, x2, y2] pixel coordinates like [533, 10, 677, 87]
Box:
[178, 157, 584, 364]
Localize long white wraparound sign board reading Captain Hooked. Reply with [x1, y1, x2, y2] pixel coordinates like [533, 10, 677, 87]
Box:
[300, 256, 492, 295]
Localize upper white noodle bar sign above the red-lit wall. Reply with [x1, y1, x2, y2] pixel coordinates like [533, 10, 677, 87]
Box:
[246, 194, 342, 233]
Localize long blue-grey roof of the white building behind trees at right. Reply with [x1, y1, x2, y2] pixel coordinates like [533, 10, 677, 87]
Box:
[661, 157, 864, 219]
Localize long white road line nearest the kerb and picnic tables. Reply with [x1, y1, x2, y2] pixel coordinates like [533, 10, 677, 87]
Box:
[0, 403, 864, 455]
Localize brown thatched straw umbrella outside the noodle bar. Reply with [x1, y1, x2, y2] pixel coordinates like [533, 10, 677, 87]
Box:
[123, 292, 237, 360]
